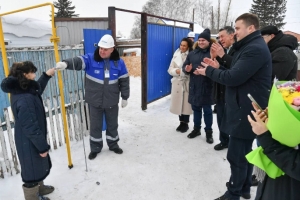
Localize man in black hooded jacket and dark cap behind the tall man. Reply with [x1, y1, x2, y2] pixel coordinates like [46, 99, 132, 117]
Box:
[261, 26, 298, 81]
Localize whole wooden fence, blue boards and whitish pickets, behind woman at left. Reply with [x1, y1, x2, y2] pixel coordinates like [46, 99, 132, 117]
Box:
[0, 49, 89, 178]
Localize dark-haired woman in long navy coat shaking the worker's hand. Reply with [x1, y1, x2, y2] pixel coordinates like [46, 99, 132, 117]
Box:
[1, 61, 55, 200]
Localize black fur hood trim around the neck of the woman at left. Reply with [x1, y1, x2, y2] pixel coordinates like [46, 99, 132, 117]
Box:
[1, 76, 41, 94]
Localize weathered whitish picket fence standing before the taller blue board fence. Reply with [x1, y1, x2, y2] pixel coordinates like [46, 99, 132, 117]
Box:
[0, 90, 89, 178]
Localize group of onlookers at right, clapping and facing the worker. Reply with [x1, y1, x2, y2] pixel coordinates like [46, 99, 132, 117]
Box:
[168, 13, 300, 200]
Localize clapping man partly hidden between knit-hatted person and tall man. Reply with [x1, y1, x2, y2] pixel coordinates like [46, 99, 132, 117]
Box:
[210, 26, 235, 151]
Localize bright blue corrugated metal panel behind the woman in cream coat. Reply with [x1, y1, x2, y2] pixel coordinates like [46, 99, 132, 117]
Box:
[147, 24, 190, 103]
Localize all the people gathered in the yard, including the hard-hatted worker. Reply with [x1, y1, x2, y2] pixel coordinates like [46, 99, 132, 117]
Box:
[1, 13, 300, 200]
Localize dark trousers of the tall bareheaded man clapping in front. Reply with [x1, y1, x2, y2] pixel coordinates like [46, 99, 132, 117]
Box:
[226, 137, 253, 200]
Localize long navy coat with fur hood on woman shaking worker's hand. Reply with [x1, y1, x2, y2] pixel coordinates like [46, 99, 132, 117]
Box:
[1, 73, 52, 183]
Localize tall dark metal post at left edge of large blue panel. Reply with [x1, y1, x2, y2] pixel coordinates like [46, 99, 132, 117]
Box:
[141, 13, 148, 110]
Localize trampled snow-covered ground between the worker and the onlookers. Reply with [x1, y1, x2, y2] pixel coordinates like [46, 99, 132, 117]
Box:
[0, 77, 256, 200]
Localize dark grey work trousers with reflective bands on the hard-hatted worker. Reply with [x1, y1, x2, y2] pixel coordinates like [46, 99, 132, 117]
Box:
[90, 105, 119, 152]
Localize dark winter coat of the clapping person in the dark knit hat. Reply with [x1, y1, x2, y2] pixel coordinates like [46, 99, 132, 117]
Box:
[182, 47, 213, 106]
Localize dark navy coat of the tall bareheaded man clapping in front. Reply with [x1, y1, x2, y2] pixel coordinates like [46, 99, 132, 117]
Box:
[206, 31, 272, 139]
